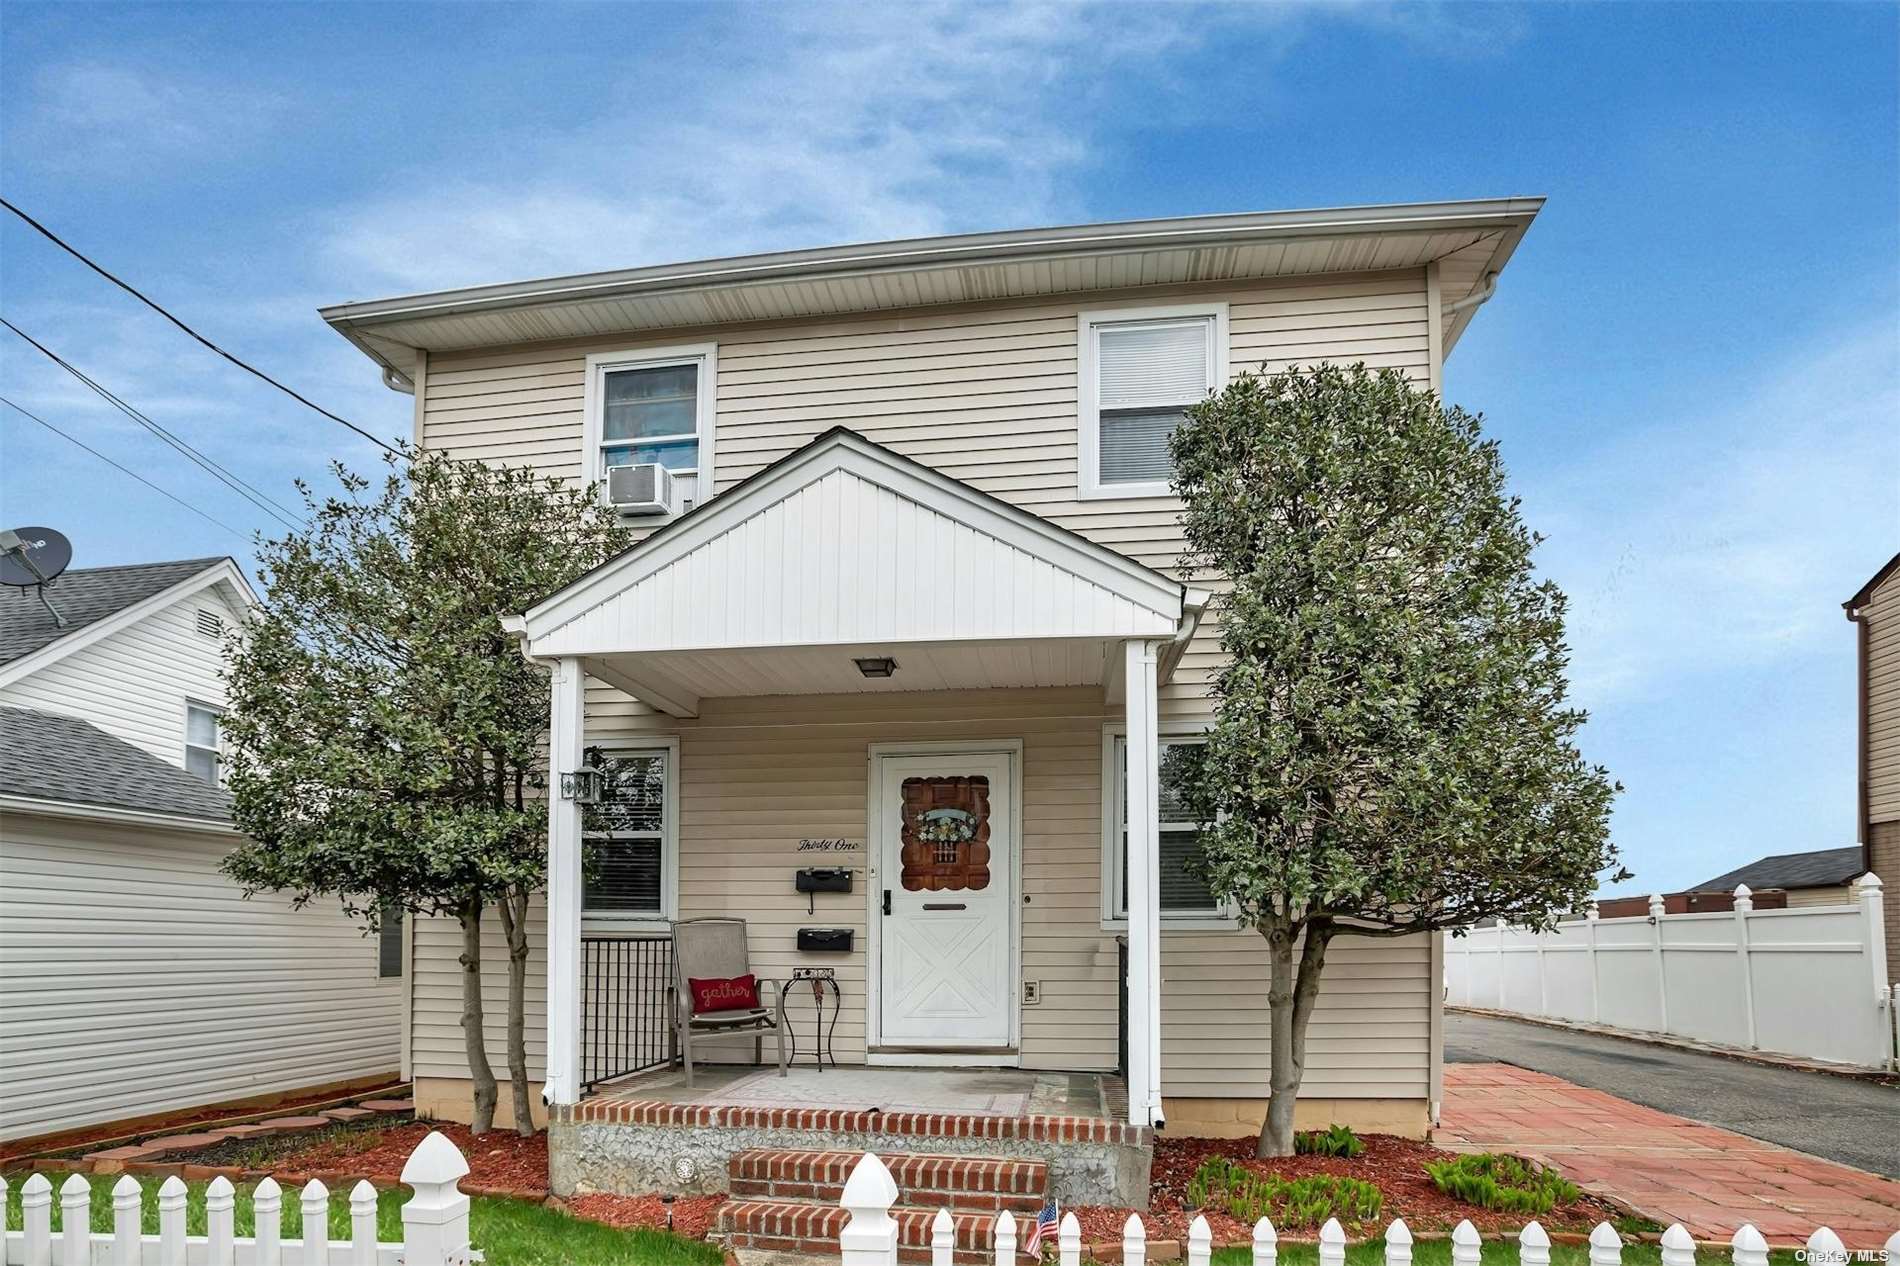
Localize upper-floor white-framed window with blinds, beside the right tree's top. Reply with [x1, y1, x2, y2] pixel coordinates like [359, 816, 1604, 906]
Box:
[1079, 304, 1227, 498]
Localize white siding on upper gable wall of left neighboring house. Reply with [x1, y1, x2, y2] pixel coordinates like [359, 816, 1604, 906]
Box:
[0, 585, 241, 766]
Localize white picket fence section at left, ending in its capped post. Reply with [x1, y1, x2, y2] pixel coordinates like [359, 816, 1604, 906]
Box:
[0, 1131, 483, 1266]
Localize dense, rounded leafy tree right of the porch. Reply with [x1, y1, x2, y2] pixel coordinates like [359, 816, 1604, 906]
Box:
[1170, 365, 1621, 1156]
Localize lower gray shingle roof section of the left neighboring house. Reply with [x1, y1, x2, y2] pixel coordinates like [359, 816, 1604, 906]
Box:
[0, 707, 230, 821]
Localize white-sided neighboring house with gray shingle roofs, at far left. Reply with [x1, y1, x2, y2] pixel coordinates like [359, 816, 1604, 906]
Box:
[0, 559, 403, 1146]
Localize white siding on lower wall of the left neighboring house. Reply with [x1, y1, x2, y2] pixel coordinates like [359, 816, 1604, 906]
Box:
[0, 812, 401, 1139]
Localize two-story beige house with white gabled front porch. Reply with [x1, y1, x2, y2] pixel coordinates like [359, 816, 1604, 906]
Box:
[323, 200, 1541, 1169]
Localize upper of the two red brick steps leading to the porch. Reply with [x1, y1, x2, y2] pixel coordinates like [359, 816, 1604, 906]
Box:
[726, 1148, 1049, 1215]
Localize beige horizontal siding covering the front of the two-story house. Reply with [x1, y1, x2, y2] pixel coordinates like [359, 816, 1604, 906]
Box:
[414, 268, 1435, 1099]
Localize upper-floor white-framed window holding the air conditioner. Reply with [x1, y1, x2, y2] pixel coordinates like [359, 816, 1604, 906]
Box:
[583, 344, 716, 509]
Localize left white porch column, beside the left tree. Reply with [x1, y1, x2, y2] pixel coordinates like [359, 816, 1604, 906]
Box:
[542, 656, 587, 1104]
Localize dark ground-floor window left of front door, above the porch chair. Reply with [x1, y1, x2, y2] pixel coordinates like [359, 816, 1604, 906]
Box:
[581, 749, 676, 918]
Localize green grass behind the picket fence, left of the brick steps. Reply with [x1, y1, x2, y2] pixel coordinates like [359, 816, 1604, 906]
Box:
[6, 1175, 722, 1266]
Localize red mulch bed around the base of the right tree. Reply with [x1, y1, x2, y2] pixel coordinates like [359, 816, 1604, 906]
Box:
[1075, 1135, 1621, 1243]
